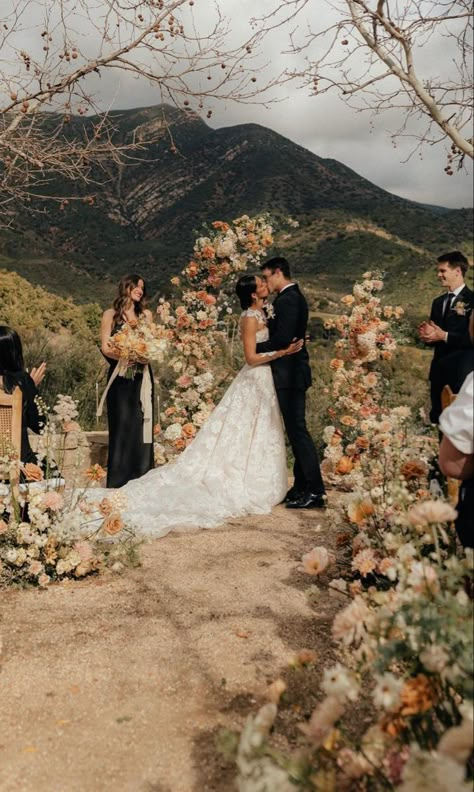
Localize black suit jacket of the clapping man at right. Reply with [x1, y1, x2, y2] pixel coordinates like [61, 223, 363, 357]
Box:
[430, 286, 474, 393]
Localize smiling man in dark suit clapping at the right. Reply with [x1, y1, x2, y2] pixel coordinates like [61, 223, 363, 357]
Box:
[418, 250, 474, 423]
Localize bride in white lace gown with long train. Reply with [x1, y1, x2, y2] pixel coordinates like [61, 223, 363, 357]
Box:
[90, 275, 302, 537]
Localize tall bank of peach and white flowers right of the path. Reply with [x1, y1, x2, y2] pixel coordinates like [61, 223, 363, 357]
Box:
[229, 273, 474, 792]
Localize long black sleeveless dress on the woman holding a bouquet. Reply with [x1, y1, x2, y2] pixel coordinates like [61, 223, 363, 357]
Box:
[106, 327, 155, 488]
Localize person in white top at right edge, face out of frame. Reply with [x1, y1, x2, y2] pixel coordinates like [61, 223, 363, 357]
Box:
[439, 315, 474, 547]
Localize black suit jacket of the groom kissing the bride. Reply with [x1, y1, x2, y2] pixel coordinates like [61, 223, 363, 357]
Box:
[257, 283, 311, 390]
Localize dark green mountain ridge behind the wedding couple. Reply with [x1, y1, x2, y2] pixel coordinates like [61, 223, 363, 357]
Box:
[0, 106, 472, 304]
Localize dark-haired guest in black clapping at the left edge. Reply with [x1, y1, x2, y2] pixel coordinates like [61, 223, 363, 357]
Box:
[0, 325, 46, 463]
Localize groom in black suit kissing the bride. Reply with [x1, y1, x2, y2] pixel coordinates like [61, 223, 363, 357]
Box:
[257, 256, 325, 509]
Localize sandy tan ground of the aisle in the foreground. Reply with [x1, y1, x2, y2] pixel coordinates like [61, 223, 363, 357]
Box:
[0, 507, 338, 792]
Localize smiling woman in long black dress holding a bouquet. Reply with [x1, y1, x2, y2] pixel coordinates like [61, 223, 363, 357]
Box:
[101, 273, 154, 488]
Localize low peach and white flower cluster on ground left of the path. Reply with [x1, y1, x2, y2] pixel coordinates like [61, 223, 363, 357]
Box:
[0, 396, 136, 587]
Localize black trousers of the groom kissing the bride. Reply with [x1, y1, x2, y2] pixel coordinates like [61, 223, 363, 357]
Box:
[277, 388, 324, 495]
